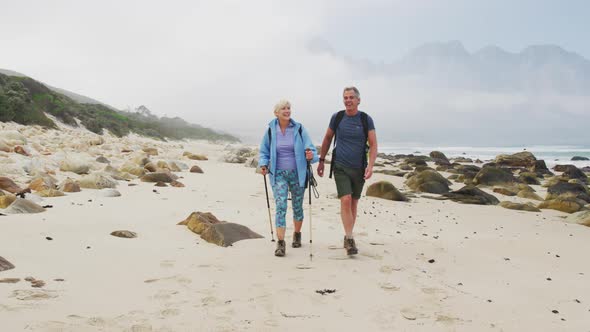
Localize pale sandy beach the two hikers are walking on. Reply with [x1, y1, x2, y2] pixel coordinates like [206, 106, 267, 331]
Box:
[0, 123, 590, 331]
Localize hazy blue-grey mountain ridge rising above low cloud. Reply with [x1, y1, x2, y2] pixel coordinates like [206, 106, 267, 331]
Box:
[308, 39, 590, 96]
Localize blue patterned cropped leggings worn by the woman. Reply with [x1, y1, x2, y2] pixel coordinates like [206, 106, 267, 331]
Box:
[272, 169, 305, 227]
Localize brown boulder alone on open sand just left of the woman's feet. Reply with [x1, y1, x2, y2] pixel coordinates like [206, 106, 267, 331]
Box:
[180, 212, 262, 247]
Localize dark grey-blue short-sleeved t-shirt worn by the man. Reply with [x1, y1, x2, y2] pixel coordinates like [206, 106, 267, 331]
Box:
[330, 111, 375, 168]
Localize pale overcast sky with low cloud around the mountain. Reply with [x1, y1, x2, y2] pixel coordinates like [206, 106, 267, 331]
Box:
[0, 0, 590, 144]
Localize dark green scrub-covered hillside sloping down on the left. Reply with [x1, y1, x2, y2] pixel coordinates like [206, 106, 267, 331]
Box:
[0, 70, 239, 142]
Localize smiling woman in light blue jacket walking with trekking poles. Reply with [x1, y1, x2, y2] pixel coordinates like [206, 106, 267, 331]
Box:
[258, 100, 318, 257]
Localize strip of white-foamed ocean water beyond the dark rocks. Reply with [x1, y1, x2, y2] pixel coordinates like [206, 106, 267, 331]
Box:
[379, 143, 590, 168]
